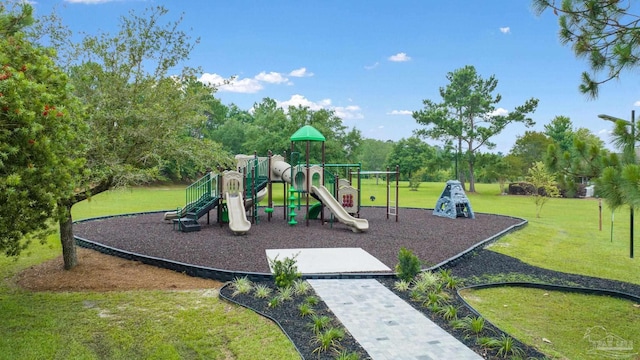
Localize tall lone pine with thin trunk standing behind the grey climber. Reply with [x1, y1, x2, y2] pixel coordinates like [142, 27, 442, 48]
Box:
[413, 65, 538, 192]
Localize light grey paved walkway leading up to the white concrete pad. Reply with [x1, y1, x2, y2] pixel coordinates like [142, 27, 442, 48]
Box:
[308, 279, 482, 360]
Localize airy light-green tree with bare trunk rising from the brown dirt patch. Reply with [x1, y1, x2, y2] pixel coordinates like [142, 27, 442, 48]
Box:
[40, 7, 230, 269]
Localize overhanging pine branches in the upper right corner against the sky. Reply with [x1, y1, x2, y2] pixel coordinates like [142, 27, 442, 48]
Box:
[533, 0, 640, 98]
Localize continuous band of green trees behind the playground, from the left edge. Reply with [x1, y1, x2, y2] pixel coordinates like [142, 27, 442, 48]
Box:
[0, 3, 631, 269]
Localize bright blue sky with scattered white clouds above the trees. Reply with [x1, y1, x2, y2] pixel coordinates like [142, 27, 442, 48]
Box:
[32, 0, 640, 153]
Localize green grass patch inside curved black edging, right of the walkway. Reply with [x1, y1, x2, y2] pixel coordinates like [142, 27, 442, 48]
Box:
[462, 288, 640, 359]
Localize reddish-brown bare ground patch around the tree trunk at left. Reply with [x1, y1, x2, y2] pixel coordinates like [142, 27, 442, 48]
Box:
[16, 248, 222, 291]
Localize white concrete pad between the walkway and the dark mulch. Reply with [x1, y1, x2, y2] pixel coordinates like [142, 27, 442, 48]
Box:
[265, 248, 391, 274]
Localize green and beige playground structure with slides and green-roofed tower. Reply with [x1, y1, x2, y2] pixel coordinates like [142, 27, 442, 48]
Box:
[164, 125, 397, 235]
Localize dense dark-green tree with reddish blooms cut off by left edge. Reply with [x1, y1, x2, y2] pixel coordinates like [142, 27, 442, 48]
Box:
[0, 3, 85, 256]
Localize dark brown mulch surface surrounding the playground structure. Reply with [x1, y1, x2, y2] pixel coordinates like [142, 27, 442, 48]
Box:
[74, 207, 522, 273]
